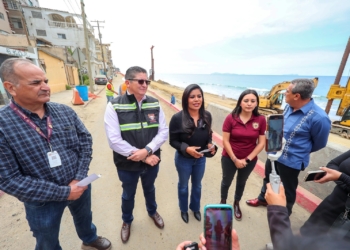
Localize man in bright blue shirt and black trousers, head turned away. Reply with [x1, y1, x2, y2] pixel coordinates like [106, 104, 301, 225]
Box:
[246, 79, 331, 215]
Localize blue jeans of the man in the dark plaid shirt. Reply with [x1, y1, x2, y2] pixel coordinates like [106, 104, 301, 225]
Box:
[24, 185, 97, 250]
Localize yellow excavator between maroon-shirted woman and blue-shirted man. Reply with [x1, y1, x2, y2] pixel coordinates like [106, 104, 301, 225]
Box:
[259, 77, 318, 115]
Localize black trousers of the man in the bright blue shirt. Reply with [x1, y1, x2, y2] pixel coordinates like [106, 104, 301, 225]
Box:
[258, 159, 300, 215]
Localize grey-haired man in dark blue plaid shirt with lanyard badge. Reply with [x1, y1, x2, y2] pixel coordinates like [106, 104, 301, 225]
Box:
[0, 58, 111, 250]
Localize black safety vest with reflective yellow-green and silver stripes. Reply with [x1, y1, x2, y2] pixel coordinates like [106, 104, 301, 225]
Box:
[111, 94, 160, 171]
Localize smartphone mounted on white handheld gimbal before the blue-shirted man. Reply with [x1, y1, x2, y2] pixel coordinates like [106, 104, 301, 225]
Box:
[265, 115, 283, 152]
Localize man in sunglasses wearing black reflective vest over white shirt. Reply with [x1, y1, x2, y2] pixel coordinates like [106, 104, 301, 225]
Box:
[104, 66, 169, 243]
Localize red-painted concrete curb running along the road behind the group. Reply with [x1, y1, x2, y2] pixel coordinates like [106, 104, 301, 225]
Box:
[148, 90, 322, 213]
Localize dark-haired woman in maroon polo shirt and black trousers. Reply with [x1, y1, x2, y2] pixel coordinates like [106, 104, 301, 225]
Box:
[220, 89, 266, 220]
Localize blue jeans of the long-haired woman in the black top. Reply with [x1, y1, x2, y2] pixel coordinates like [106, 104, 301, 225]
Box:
[175, 151, 206, 213]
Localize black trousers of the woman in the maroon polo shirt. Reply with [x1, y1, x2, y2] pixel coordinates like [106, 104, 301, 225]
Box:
[221, 156, 256, 201]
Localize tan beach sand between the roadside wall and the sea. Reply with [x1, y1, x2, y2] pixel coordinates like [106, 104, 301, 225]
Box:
[150, 80, 350, 149]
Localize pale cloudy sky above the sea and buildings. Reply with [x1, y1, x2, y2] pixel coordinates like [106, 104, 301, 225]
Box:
[39, 0, 350, 76]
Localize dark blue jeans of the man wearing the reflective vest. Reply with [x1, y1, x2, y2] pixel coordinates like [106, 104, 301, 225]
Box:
[117, 164, 159, 224]
